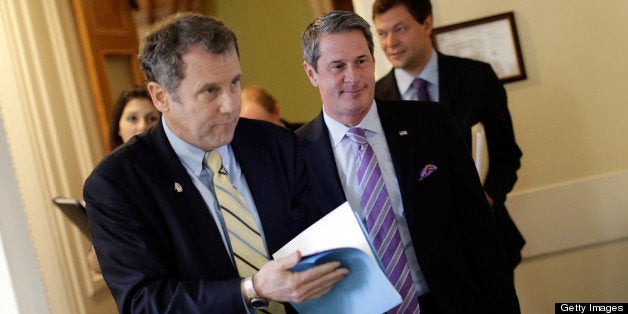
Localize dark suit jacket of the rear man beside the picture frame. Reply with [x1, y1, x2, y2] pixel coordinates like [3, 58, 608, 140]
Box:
[375, 53, 525, 267]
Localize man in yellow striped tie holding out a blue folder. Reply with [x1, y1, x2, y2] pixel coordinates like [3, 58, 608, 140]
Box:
[84, 13, 347, 313]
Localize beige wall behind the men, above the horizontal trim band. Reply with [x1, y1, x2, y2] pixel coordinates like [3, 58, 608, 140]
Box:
[213, 0, 628, 201]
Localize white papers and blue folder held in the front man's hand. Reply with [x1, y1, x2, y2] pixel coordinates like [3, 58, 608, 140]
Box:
[273, 203, 401, 313]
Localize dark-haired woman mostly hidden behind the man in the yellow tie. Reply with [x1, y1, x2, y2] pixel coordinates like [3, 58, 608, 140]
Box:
[87, 88, 161, 273]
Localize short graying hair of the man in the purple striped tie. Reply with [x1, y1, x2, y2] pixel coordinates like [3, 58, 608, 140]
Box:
[301, 11, 374, 71]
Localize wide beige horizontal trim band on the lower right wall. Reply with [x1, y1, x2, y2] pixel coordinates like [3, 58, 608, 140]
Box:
[506, 171, 628, 257]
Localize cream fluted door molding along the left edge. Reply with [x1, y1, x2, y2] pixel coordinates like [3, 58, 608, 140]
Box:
[0, 0, 110, 313]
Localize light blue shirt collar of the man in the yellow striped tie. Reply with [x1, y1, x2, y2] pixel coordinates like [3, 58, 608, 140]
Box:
[161, 115, 233, 176]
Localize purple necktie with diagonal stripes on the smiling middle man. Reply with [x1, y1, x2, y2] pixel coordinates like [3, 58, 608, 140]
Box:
[346, 128, 419, 313]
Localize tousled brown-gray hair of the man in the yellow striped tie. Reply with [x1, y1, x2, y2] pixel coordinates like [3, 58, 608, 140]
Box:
[138, 12, 240, 98]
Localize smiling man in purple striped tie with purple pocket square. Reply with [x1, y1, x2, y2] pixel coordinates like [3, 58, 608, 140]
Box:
[297, 11, 519, 314]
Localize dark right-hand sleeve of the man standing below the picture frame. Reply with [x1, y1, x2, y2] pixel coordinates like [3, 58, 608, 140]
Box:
[478, 65, 522, 203]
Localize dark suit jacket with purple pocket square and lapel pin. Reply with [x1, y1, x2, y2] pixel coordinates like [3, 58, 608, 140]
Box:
[297, 100, 519, 314]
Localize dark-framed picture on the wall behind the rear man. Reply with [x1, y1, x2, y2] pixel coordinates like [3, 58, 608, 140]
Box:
[432, 12, 527, 83]
